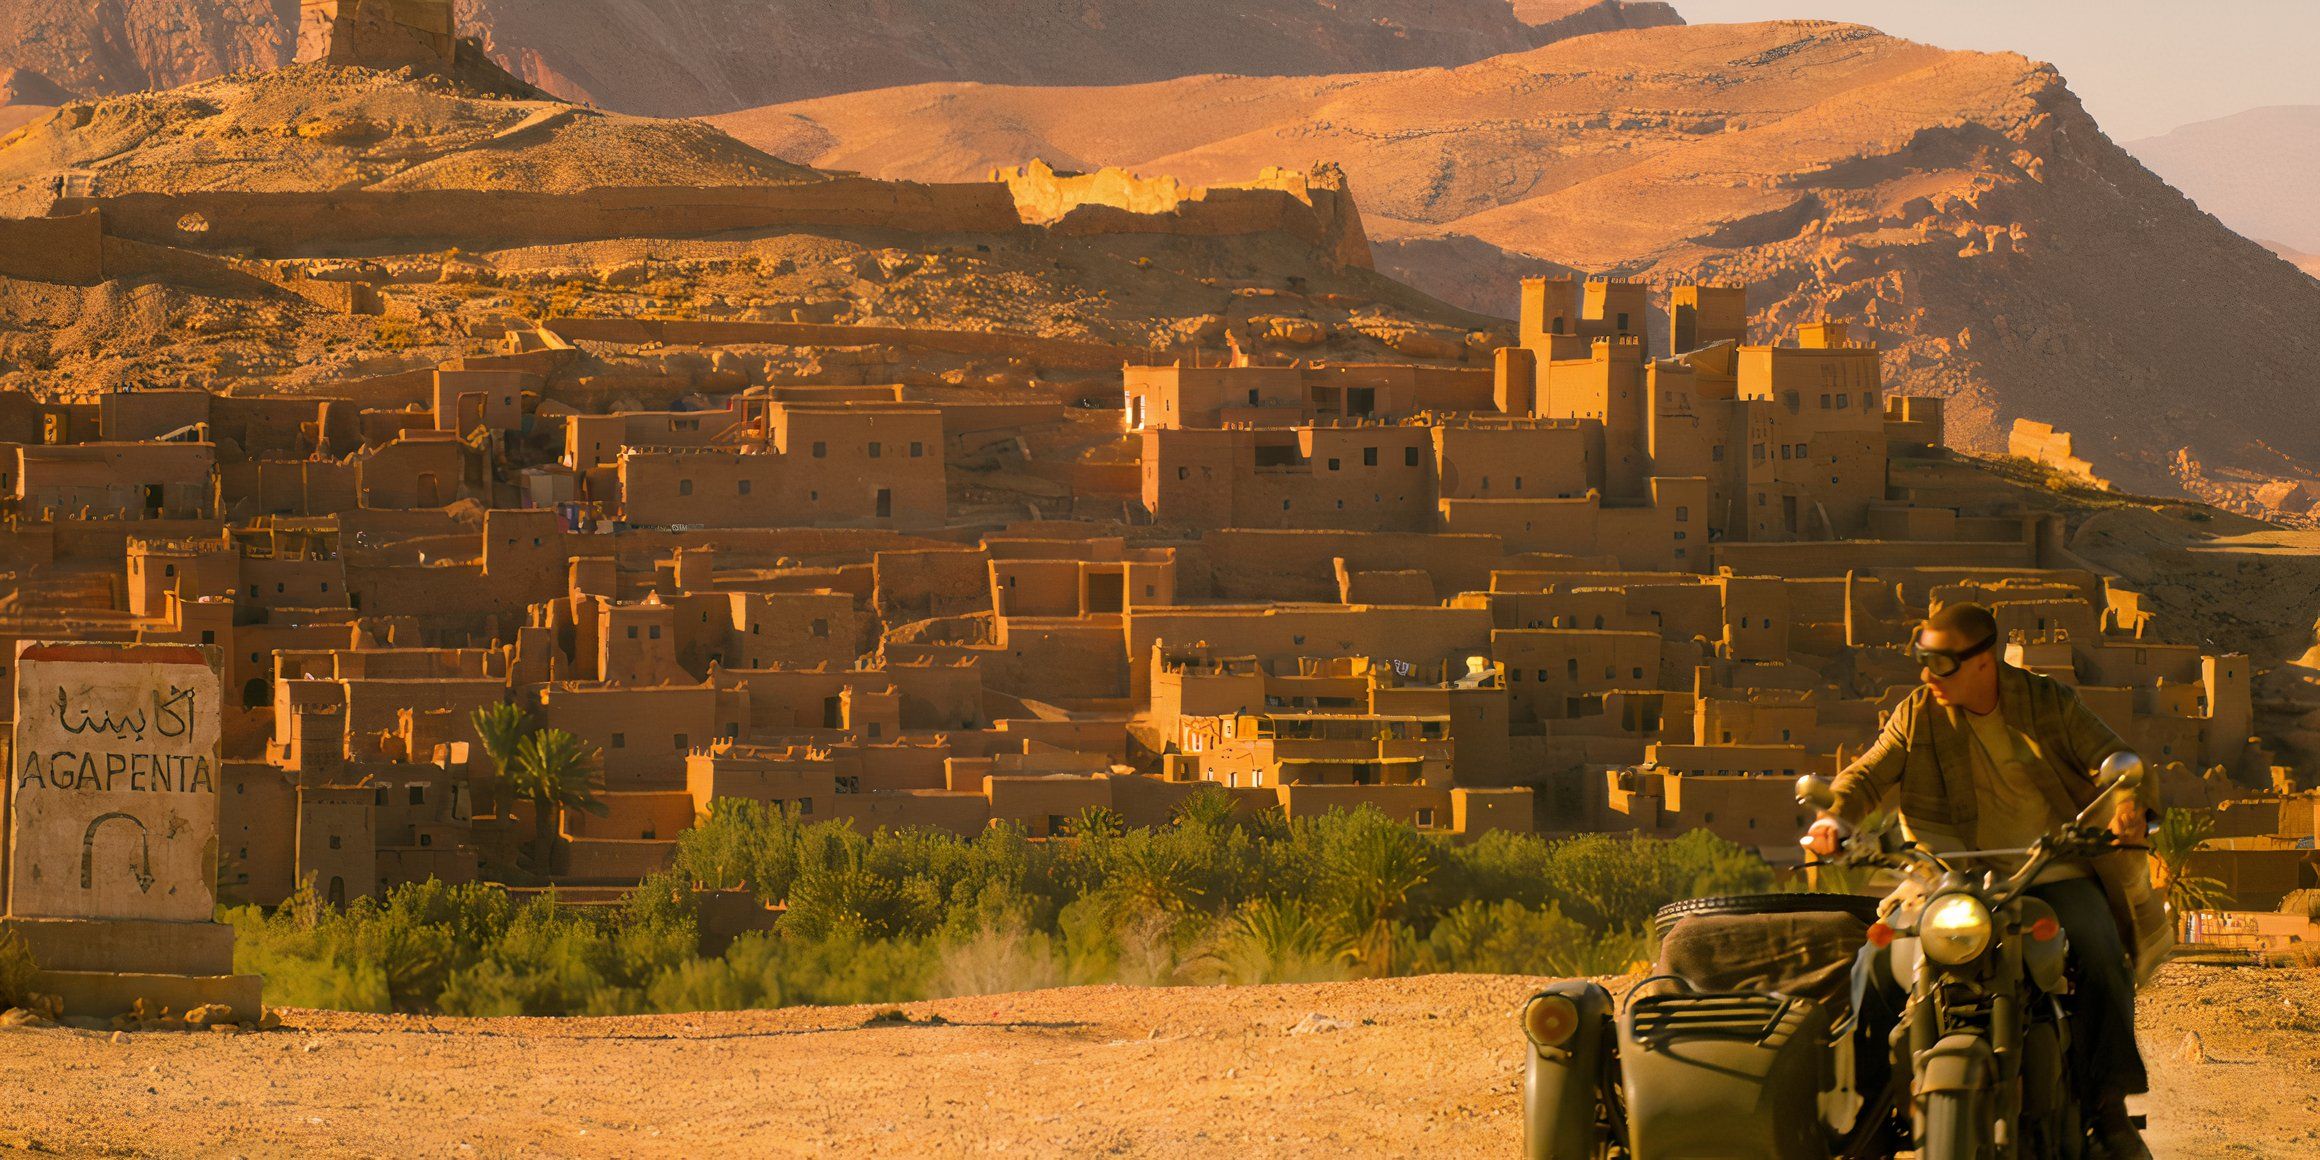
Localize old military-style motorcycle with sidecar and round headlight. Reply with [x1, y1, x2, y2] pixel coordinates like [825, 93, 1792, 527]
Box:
[1522, 754, 2144, 1160]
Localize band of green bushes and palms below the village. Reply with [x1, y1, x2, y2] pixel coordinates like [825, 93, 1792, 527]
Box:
[235, 807, 1770, 1016]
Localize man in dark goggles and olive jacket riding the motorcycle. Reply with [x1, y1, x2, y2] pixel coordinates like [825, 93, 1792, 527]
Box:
[1803, 603, 2174, 1158]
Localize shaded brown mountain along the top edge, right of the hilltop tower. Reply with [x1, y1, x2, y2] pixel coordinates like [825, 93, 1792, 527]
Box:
[459, 0, 1677, 116]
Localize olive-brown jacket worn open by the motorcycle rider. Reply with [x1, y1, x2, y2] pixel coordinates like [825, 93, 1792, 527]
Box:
[1830, 661, 2174, 977]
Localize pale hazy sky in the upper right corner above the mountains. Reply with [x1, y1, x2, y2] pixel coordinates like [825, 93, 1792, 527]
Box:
[1673, 0, 2320, 142]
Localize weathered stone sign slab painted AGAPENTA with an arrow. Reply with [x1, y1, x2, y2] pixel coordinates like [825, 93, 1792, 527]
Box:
[7, 640, 223, 923]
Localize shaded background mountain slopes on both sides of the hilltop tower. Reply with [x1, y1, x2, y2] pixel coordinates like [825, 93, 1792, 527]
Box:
[0, 0, 1682, 116]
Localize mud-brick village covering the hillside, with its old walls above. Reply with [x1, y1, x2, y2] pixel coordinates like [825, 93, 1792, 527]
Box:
[0, 0, 2320, 955]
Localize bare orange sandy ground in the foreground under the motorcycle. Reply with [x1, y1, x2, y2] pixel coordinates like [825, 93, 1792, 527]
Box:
[0, 965, 2320, 1158]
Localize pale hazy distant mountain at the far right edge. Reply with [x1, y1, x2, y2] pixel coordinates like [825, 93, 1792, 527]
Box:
[2127, 104, 2320, 253]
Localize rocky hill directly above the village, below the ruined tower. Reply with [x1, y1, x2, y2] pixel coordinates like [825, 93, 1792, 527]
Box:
[0, 65, 1506, 408]
